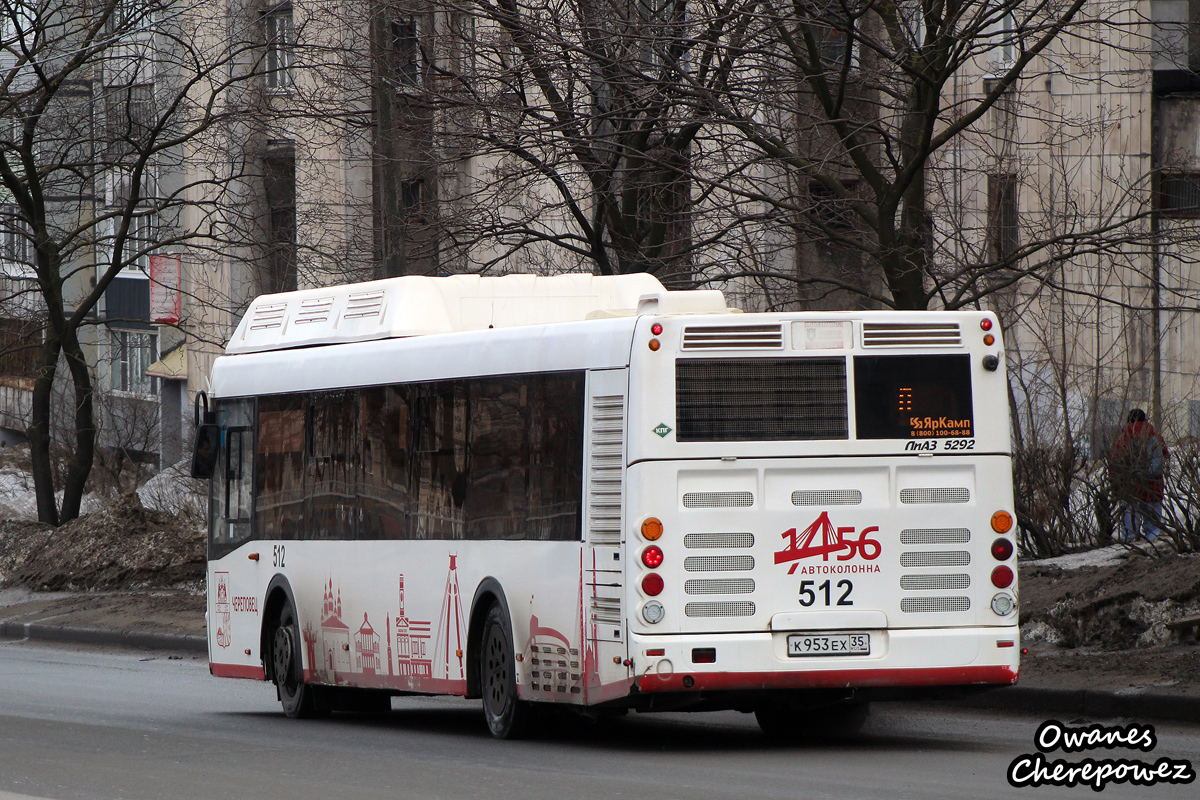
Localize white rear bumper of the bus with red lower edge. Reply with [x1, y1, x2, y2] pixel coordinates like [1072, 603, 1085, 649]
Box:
[630, 625, 1020, 692]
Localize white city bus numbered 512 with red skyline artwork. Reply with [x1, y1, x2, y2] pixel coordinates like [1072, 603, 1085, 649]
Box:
[193, 275, 1019, 736]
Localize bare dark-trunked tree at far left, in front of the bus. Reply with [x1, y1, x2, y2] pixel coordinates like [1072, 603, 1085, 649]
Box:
[0, 0, 260, 524]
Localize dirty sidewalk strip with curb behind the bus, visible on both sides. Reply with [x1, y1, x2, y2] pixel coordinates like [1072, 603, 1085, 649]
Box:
[0, 589, 1200, 723]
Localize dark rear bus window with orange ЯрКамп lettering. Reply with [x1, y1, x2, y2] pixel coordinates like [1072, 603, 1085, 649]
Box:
[854, 355, 974, 439]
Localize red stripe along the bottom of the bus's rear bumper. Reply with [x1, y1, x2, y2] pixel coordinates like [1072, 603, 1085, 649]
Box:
[637, 667, 1016, 692]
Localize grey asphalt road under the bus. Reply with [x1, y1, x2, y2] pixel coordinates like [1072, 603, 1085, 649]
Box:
[0, 642, 1200, 800]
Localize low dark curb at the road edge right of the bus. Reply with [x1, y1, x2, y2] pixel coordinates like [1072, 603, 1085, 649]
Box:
[955, 686, 1200, 722]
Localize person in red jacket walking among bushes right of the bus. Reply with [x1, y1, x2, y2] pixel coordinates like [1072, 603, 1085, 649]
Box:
[1109, 408, 1168, 542]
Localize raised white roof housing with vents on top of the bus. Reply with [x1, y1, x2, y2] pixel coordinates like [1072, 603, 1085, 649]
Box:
[226, 273, 736, 355]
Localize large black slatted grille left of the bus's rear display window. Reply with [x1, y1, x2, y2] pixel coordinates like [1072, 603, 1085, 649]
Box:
[676, 357, 848, 441]
